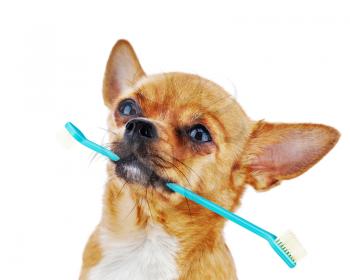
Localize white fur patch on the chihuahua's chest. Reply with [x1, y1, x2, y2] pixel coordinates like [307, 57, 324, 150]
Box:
[88, 225, 179, 280]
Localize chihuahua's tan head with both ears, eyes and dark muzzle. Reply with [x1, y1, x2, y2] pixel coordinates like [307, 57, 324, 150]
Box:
[103, 40, 339, 209]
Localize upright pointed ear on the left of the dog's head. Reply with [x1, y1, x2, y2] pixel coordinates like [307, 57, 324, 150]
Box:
[103, 40, 145, 108]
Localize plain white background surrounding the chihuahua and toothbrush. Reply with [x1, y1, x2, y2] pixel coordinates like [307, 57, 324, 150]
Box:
[0, 0, 350, 280]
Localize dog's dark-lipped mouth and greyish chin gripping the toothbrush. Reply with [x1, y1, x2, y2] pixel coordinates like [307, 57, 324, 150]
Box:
[115, 154, 172, 192]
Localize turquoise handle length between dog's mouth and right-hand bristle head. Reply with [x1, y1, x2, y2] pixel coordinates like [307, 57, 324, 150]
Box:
[167, 183, 277, 241]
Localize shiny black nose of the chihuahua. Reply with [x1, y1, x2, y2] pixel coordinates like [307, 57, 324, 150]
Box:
[124, 118, 157, 140]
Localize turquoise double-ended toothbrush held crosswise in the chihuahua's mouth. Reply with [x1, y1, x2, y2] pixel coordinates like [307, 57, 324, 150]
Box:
[65, 122, 306, 268]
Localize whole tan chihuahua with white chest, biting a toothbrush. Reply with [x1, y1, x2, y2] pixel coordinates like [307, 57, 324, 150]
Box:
[80, 40, 339, 280]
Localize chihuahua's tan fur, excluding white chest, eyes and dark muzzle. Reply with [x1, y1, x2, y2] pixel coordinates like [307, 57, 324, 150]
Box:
[80, 40, 339, 280]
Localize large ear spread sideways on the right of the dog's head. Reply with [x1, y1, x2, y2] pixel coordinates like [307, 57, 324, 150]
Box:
[242, 121, 340, 191]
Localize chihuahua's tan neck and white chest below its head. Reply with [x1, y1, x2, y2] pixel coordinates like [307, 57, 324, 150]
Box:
[89, 179, 241, 279]
